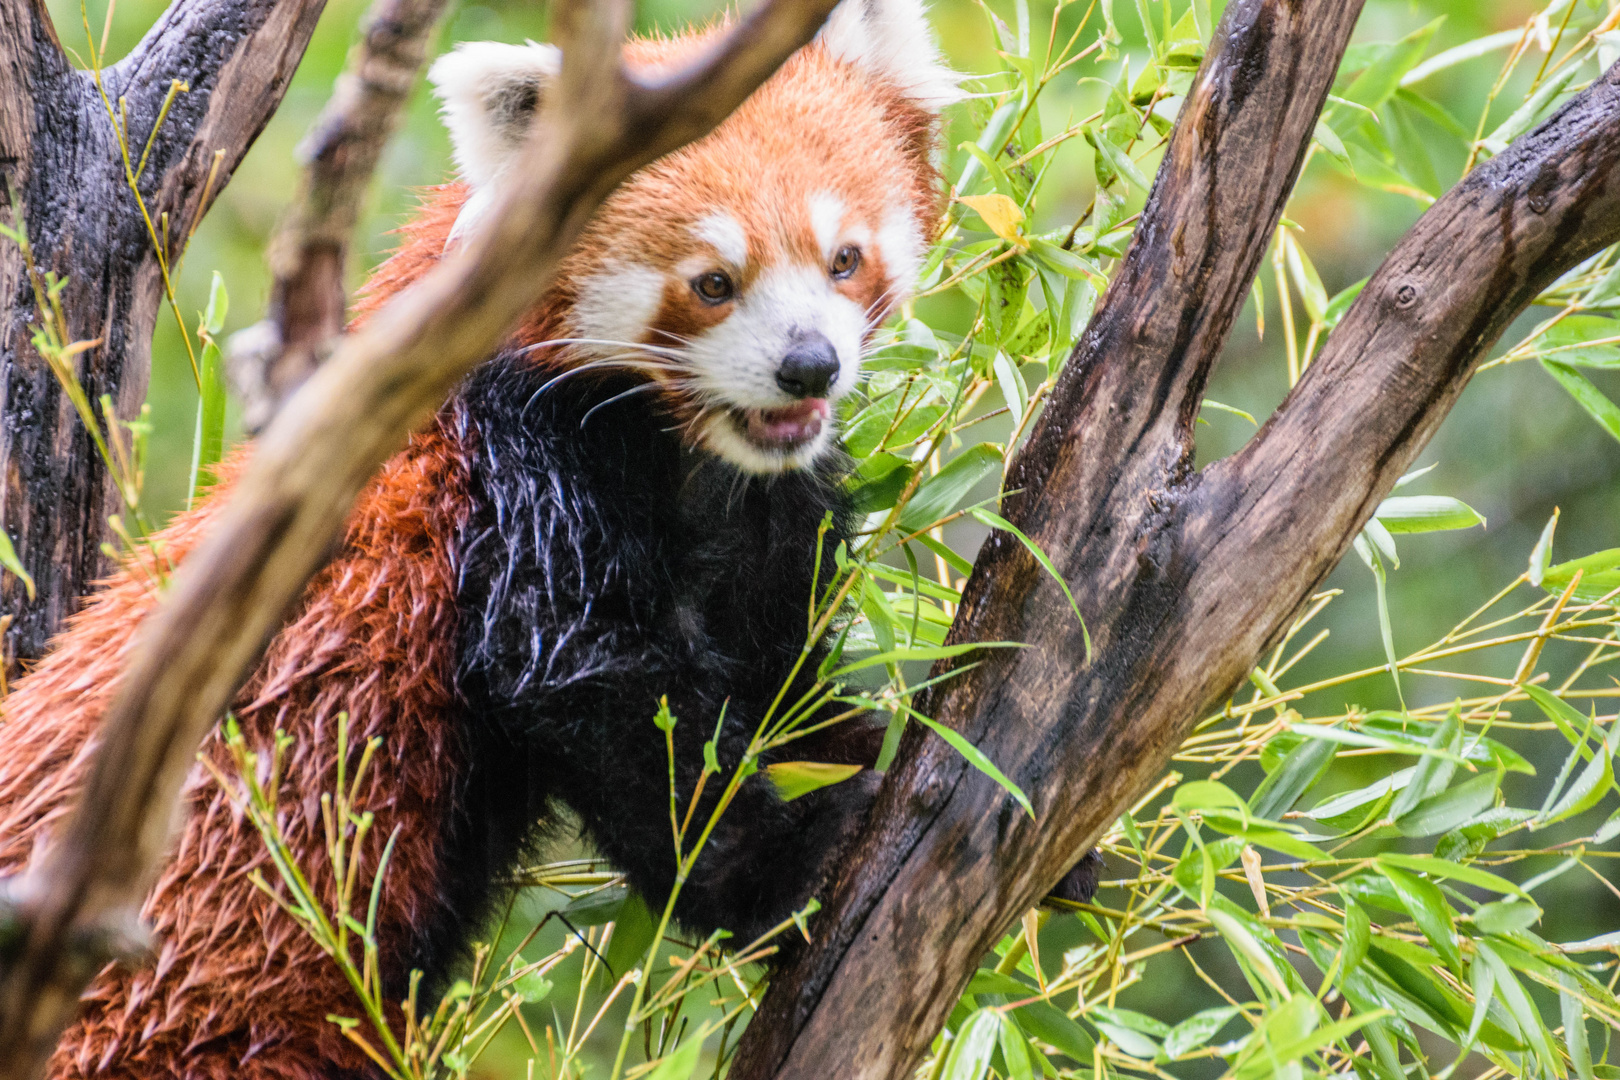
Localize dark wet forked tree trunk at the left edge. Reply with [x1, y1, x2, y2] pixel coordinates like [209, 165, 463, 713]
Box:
[0, 0, 326, 674]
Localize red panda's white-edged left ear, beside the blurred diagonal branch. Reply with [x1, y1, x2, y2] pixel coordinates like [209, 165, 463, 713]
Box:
[428, 40, 562, 238]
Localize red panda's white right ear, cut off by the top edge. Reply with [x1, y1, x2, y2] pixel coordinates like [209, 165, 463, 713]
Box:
[821, 0, 966, 112]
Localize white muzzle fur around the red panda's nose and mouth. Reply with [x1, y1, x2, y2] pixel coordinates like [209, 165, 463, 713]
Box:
[684, 266, 867, 473]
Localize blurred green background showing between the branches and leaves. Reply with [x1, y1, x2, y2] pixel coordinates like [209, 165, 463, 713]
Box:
[49, 0, 1620, 1075]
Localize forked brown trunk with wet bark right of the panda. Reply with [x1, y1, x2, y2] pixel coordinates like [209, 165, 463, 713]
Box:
[731, 0, 1620, 1080]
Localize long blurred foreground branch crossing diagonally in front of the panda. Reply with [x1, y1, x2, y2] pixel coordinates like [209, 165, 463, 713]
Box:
[0, 0, 834, 1080]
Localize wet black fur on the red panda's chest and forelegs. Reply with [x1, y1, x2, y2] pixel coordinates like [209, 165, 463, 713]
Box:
[434, 358, 851, 971]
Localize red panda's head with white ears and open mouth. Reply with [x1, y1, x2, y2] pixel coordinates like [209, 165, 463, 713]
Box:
[429, 0, 961, 473]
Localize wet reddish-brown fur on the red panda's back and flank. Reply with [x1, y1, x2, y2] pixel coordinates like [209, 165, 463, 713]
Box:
[0, 432, 465, 1080]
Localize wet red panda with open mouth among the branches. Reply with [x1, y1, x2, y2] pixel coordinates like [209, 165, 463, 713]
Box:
[0, 0, 959, 1080]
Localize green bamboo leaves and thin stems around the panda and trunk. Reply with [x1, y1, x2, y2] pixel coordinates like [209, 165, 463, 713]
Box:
[12, 0, 1620, 1080]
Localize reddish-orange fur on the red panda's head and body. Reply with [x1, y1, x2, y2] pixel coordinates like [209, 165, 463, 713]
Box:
[0, 23, 938, 1080]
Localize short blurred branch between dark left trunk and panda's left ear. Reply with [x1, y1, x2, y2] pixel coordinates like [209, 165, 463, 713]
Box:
[230, 0, 447, 432]
